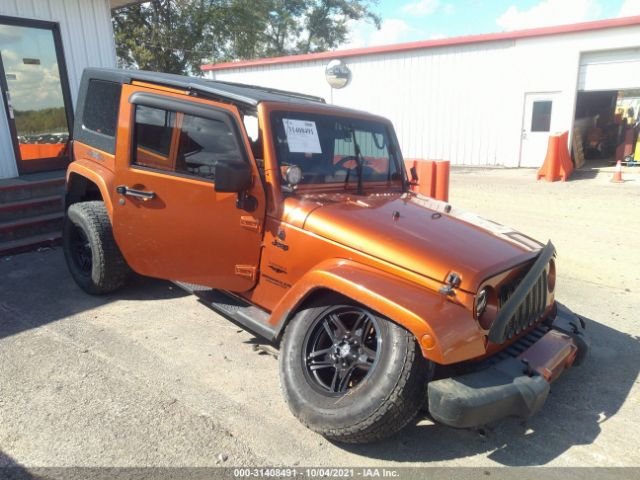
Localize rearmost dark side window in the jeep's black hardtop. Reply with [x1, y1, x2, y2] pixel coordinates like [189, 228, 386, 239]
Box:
[82, 80, 121, 137]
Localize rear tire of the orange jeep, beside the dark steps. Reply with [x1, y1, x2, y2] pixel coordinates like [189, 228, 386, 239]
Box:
[62, 201, 130, 295]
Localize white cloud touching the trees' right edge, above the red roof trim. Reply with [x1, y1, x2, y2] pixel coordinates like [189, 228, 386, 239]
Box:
[340, 18, 423, 49]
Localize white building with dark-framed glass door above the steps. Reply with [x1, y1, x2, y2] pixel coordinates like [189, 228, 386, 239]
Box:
[0, 0, 136, 178]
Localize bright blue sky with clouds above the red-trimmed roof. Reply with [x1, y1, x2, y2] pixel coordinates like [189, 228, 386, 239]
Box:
[340, 0, 640, 49]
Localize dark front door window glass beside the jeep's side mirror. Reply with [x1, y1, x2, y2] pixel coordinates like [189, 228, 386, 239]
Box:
[176, 115, 242, 180]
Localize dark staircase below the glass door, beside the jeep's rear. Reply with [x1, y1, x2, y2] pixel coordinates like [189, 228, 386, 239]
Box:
[0, 171, 65, 256]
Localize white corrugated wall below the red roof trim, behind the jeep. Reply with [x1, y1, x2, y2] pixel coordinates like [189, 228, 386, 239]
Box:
[208, 26, 640, 167]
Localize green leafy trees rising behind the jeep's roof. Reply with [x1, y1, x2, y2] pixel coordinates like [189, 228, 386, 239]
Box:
[113, 0, 380, 74]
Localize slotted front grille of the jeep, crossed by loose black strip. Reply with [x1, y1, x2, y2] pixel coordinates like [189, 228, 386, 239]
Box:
[498, 270, 547, 339]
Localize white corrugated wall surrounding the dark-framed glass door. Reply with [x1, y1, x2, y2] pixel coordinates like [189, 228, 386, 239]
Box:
[0, 0, 116, 178]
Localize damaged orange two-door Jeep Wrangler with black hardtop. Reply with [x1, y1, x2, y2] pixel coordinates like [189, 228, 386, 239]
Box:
[64, 69, 589, 443]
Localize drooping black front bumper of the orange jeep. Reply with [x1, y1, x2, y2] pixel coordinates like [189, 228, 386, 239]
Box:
[428, 303, 590, 428]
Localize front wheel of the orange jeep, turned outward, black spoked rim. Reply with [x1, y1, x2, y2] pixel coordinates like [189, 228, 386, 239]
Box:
[280, 295, 434, 443]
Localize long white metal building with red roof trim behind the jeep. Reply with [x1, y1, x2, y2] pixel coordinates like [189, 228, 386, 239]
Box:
[202, 17, 640, 167]
